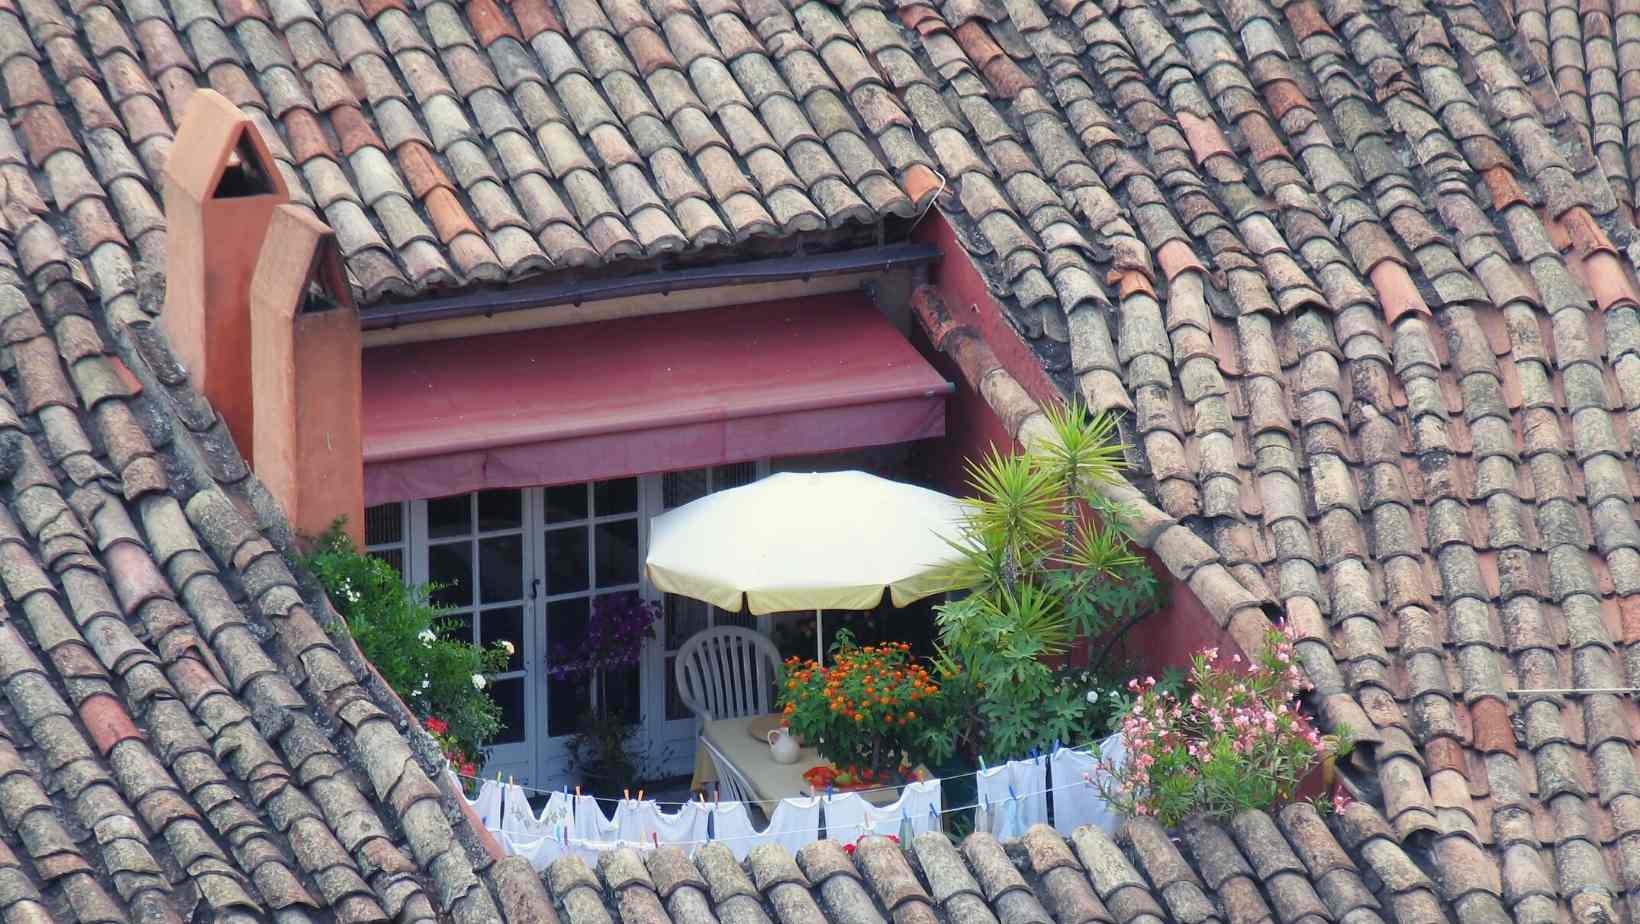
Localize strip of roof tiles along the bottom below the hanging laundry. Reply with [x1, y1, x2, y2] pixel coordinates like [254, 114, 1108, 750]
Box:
[546, 814, 1449, 924]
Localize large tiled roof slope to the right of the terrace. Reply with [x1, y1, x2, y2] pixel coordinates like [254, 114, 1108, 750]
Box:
[898, 0, 1640, 924]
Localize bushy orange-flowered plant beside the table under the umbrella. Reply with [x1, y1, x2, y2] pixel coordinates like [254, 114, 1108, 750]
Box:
[779, 630, 951, 773]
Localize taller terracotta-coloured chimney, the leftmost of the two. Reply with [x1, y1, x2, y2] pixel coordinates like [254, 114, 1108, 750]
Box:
[161, 89, 290, 458]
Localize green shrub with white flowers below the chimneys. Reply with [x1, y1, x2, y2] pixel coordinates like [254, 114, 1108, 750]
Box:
[305, 520, 512, 771]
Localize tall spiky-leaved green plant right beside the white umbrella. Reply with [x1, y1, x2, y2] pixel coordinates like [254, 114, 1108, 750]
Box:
[938, 407, 1156, 760]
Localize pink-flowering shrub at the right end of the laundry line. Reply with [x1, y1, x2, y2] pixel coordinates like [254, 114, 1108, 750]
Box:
[1102, 632, 1343, 827]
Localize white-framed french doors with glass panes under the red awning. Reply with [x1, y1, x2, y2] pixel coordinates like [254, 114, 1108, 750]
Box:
[366, 463, 768, 788]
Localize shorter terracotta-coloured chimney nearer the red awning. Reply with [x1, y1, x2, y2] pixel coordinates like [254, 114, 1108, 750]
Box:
[249, 205, 364, 548]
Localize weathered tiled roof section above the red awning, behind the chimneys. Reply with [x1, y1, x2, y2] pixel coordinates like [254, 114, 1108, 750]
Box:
[0, 0, 938, 300]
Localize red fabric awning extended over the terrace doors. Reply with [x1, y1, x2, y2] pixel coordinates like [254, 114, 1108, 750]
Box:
[364, 294, 951, 504]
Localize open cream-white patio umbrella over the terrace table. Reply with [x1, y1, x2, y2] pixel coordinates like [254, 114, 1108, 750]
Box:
[646, 471, 964, 660]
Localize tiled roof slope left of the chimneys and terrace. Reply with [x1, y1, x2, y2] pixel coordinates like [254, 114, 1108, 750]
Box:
[0, 106, 549, 924]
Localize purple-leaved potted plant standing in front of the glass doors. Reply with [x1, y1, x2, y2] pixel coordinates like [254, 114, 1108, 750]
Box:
[546, 591, 661, 794]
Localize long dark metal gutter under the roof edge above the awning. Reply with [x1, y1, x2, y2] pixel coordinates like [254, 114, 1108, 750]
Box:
[359, 243, 940, 330]
